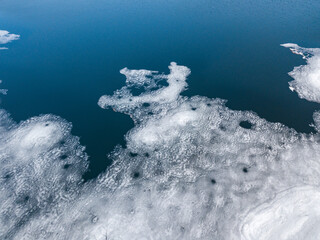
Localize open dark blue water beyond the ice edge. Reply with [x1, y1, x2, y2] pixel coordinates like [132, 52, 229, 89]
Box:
[0, 0, 320, 178]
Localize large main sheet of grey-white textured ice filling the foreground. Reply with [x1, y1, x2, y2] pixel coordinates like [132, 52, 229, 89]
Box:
[0, 49, 320, 240]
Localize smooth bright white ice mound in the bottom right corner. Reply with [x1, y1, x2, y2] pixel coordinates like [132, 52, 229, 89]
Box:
[241, 187, 320, 240]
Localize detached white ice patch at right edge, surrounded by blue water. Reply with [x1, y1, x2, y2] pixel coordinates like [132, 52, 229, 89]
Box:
[281, 43, 320, 103]
